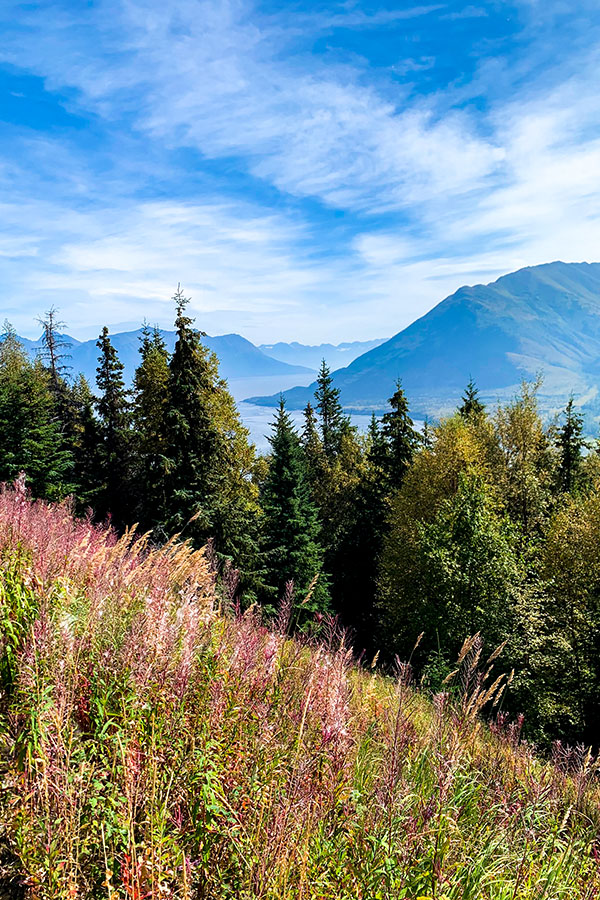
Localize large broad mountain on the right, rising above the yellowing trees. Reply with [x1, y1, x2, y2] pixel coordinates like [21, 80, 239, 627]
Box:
[249, 262, 600, 417]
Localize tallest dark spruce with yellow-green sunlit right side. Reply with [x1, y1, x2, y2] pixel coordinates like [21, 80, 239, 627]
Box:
[162, 289, 261, 591]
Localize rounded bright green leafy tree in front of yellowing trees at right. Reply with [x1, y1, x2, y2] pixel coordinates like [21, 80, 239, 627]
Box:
[380, 476, 520, 659]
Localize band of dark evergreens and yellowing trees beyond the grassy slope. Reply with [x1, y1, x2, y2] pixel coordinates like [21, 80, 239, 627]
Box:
[0, 289, 600, 744]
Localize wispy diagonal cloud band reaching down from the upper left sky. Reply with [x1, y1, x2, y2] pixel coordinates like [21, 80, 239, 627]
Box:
[4, 0, 498, 210]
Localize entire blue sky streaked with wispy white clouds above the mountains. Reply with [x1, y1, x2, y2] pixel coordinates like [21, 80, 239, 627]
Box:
[0, 0, 600, 343]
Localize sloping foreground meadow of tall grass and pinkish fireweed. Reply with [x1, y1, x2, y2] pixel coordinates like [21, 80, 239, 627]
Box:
[0, 474, 600, 900]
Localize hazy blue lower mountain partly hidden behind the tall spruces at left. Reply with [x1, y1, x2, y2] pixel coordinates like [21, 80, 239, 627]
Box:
[19, 329, 311, 386]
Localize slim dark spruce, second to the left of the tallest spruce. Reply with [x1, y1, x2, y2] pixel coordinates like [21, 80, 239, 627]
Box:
[96, 326, 131, 526]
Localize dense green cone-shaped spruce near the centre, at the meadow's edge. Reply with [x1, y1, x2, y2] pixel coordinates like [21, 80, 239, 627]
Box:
[262, 397, 329, 625]
